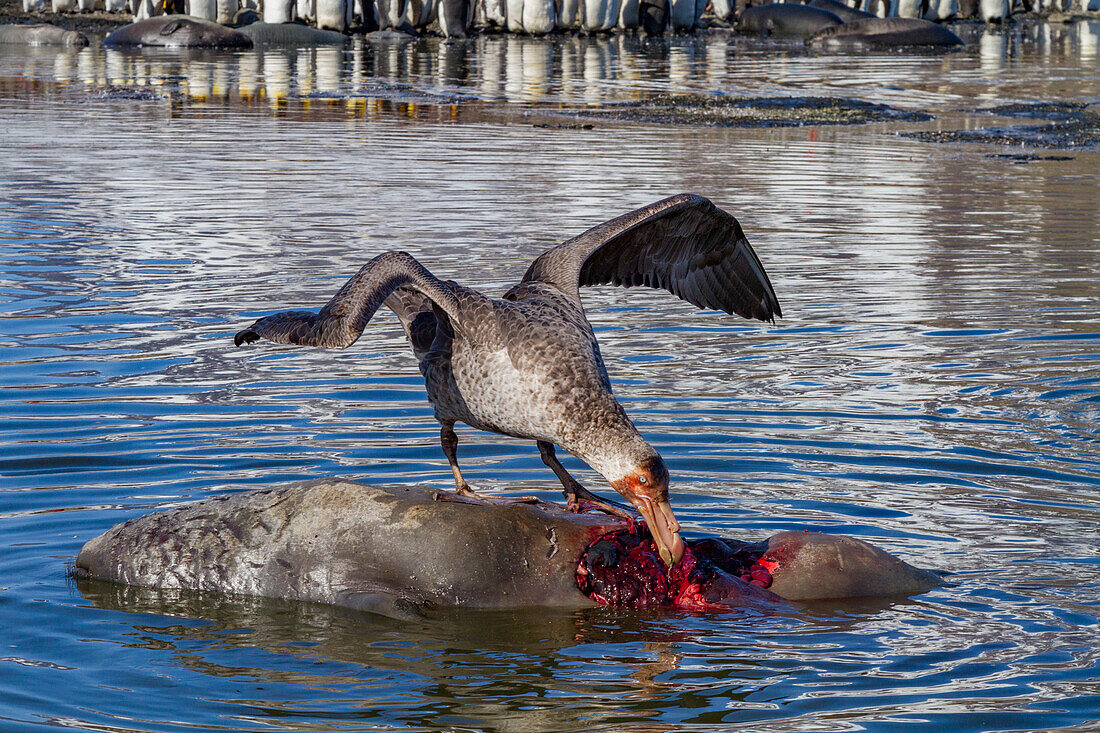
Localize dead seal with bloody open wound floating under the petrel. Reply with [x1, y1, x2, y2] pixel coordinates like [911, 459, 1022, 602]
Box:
[74, 480, 938, 617]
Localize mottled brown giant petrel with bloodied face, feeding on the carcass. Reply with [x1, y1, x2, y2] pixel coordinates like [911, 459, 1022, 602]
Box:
[234, 194, 782, 561]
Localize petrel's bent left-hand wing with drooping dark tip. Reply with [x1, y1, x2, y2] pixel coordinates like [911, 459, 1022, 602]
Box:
[233, 252, 459, 349]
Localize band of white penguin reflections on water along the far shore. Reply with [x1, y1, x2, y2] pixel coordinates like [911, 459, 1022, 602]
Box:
[6, 21, 1100, 110]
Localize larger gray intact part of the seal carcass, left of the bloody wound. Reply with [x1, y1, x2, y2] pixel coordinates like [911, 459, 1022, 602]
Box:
[76, 480, 624, 617]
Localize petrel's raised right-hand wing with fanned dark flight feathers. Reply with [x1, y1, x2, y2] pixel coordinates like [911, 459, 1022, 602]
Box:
[524, 194, 783, 321]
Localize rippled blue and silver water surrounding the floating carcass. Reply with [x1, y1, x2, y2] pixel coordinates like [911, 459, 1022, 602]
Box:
[0, 22, 1100, 731]
